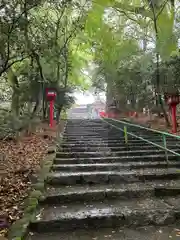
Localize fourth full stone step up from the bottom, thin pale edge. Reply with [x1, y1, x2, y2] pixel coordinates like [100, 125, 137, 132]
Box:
[52, 161, 180, 172]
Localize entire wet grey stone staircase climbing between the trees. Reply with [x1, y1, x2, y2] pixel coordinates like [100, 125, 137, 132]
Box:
[28, 120, 180, 240]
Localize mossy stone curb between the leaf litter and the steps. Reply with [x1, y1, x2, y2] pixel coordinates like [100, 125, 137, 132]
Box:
[8, 121, 67, 240]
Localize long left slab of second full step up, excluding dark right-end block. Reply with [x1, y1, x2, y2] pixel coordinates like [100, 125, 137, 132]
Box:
[41, 184, 153, 204]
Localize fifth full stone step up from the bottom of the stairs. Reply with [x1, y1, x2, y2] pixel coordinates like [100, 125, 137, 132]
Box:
[54, 154, 179, 164]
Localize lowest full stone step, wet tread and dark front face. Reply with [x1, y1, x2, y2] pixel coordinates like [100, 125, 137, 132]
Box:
[30, 198, 180, 232]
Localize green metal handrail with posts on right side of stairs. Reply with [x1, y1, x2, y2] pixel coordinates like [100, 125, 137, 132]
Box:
[102, 118, 180, 162]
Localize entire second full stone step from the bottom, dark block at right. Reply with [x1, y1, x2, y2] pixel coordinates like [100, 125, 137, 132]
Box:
[41, 180, 180, 204]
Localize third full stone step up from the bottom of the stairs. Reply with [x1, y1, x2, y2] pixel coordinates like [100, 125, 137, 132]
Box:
[47, 168, 180, 185]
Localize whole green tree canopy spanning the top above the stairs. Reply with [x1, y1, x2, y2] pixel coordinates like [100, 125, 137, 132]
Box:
[0, 0, 180, 129]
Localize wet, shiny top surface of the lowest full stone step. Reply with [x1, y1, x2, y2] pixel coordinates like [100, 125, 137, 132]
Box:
[34, 199, 172, 221]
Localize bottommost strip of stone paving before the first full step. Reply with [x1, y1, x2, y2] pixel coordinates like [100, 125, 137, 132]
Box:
[28, 224, 180, 240]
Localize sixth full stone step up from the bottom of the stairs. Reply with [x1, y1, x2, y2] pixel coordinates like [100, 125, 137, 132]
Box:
[56, 148, 180, 158]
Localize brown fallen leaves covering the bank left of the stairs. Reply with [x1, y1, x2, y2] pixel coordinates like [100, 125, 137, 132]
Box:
[0, 124, 56, 237]
